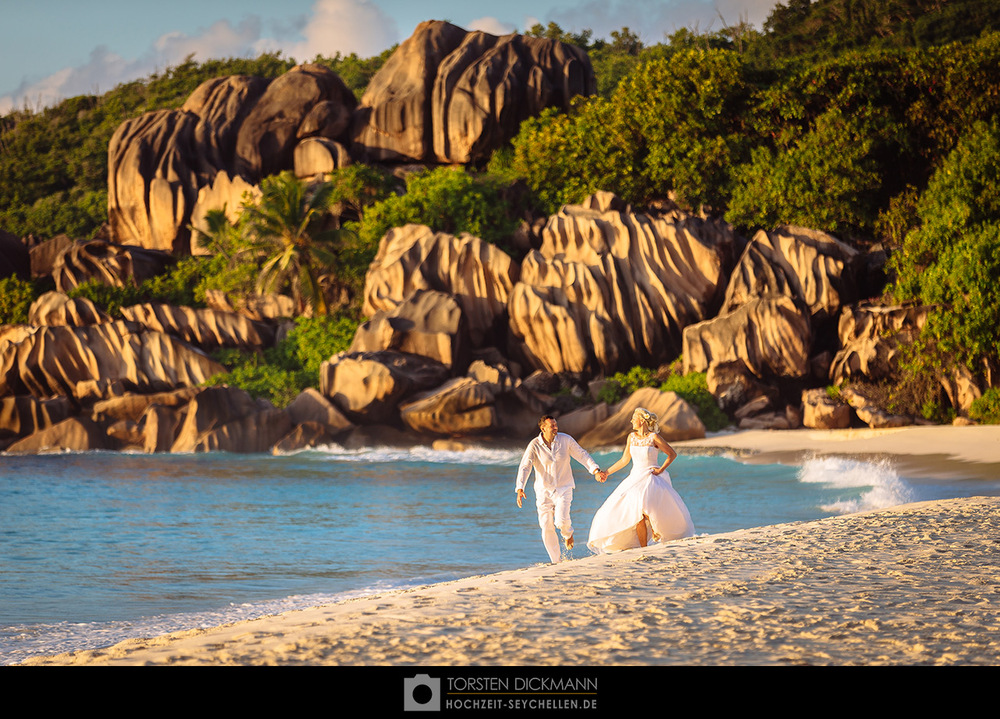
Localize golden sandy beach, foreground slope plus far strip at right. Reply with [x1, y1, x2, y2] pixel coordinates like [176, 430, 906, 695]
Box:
[15, 427, 1000, 667]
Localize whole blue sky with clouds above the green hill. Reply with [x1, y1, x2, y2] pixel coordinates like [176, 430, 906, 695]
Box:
[0, 0, 776, 114]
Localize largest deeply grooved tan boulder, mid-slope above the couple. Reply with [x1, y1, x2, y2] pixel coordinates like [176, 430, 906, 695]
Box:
[508, 198, 735, 374]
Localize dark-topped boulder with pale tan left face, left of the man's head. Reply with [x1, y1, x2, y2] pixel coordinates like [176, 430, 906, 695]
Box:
[319, 351, 449, 424]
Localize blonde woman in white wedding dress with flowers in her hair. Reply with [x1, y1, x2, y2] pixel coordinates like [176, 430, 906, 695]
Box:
[587, 407, 694, 552]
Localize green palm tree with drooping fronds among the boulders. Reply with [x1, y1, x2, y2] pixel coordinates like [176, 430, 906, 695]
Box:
[243, 171, 342, 315]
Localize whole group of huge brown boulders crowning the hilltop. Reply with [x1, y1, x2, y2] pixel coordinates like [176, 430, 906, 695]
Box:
[108, 21, 596, 254]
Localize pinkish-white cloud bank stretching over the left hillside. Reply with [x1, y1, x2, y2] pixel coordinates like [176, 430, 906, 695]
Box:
[0, 0, 399, 114]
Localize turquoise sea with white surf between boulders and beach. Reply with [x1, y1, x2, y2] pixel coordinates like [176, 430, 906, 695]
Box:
[0, 445, 1000, 665]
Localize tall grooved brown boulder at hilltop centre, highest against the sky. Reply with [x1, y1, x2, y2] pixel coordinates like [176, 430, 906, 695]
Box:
[352, 21, 596, 163]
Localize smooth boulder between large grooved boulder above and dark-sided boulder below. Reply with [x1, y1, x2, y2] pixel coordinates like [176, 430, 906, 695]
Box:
[350, 290, 469, 372]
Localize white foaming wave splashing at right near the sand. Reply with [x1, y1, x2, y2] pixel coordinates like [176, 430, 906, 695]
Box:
[799, 457, 916, 514]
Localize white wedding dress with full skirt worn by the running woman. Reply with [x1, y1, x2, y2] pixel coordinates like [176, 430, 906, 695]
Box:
[587, 434, 694, 552]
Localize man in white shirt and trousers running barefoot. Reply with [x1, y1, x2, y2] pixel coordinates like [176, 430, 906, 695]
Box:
[514, 415, 608, 562]
